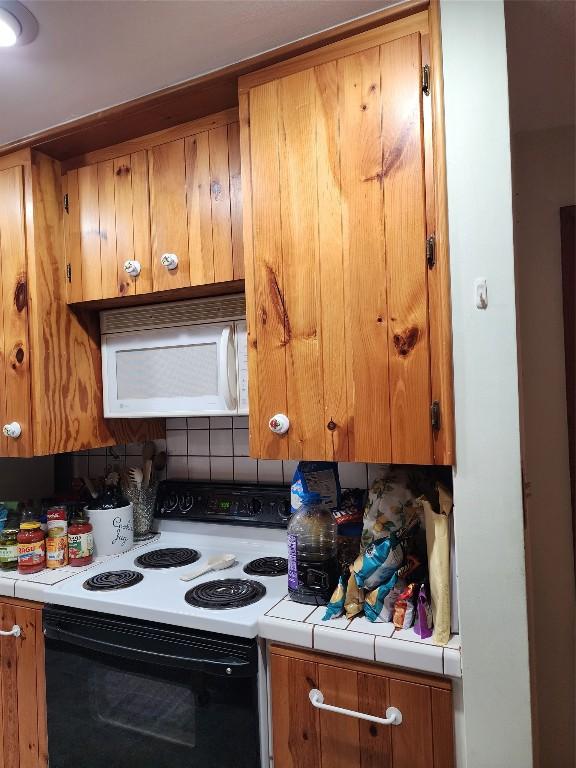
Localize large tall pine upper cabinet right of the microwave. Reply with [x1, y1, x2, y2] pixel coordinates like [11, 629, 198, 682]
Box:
[240, 12, 453, 464]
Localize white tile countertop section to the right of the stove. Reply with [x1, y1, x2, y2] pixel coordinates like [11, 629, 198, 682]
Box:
[259, 597, 462, 677]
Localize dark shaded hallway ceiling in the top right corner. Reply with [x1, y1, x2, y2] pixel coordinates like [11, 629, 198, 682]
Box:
[505, 0, 576, 133]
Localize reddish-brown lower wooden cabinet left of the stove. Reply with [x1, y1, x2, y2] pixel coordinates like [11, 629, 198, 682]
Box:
[0, 599, 48, 768]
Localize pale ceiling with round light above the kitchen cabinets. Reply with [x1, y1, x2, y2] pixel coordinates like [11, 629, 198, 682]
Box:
[0, 0, 397, 145]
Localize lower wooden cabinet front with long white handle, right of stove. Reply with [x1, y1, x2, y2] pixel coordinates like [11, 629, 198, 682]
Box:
[270, 645, 454, 768]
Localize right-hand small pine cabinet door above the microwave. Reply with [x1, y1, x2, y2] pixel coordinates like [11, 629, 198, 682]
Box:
[148, 122, 244, 291]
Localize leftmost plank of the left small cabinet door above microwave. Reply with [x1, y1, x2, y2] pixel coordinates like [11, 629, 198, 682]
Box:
[78, 165, 102, 301]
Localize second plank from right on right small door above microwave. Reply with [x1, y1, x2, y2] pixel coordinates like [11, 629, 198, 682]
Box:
[208, 125, 234, 283]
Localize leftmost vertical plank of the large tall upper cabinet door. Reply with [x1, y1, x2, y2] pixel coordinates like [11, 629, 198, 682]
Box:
[246, 82, 288, 459]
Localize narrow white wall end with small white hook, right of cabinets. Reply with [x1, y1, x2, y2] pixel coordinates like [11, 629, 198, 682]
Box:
[441, 0, 532, 768]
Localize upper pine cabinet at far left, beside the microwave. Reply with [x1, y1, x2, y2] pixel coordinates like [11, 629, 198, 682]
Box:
[0, 150, 164, 456]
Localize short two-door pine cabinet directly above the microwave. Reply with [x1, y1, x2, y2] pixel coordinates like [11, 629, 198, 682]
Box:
[64, 110, 244, 303]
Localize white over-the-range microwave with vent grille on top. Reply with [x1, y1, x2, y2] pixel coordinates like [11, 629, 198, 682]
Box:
[100, 294, 248, 419]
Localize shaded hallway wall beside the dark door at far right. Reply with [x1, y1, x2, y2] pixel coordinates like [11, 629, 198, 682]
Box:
[512, 123, 576, 768]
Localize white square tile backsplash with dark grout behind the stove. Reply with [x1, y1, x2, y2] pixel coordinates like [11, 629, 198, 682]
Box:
[74, 416, 382, 488]
